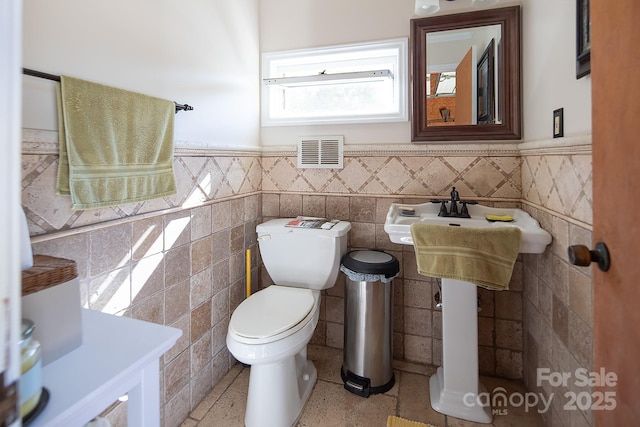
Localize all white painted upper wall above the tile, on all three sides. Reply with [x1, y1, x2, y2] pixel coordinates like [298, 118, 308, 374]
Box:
[23, 0, 591, 147]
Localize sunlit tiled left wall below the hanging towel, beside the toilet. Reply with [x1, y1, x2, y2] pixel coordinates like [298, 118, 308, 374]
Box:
[22, 132, 262, 427]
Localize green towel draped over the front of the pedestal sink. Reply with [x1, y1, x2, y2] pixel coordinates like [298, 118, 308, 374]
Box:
[411, 222, 520, 290]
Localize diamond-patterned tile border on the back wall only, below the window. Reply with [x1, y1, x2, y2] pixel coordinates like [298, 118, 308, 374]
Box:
[262, 154, 522, 199]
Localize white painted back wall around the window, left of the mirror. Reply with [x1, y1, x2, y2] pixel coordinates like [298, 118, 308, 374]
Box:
[260, 0, 414, 146]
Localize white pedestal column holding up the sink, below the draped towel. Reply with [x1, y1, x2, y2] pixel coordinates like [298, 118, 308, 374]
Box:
[429, 279, 492, 423]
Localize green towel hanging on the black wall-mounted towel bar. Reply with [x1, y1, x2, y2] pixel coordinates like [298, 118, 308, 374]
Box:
[56, 76, 176, 209]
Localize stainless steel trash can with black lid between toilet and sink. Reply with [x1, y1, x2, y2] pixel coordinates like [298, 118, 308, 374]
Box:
[340, 250, 400, 397]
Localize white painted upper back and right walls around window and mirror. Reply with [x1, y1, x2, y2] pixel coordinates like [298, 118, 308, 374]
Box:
[260, 0, 591, 146]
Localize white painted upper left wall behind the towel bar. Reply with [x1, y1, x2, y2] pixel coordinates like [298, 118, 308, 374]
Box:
[23, 0, 259, 147]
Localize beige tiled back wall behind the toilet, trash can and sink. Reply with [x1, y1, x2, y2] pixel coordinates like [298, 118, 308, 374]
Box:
[262, 147, 523, 379]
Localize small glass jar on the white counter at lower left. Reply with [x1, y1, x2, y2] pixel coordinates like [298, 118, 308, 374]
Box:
[19, 319, 42, 418]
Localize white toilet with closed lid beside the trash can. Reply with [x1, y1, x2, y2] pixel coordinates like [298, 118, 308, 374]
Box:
[227, 218, 351, 427]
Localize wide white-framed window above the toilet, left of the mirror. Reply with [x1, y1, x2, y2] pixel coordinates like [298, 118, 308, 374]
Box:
[262, 39, 407, 126]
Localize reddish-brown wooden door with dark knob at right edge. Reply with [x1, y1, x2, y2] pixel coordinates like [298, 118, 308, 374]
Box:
[592, 0, 640, 427]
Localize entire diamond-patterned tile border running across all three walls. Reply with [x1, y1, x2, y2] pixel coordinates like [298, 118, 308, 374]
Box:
[22, 129, 592, 235]
